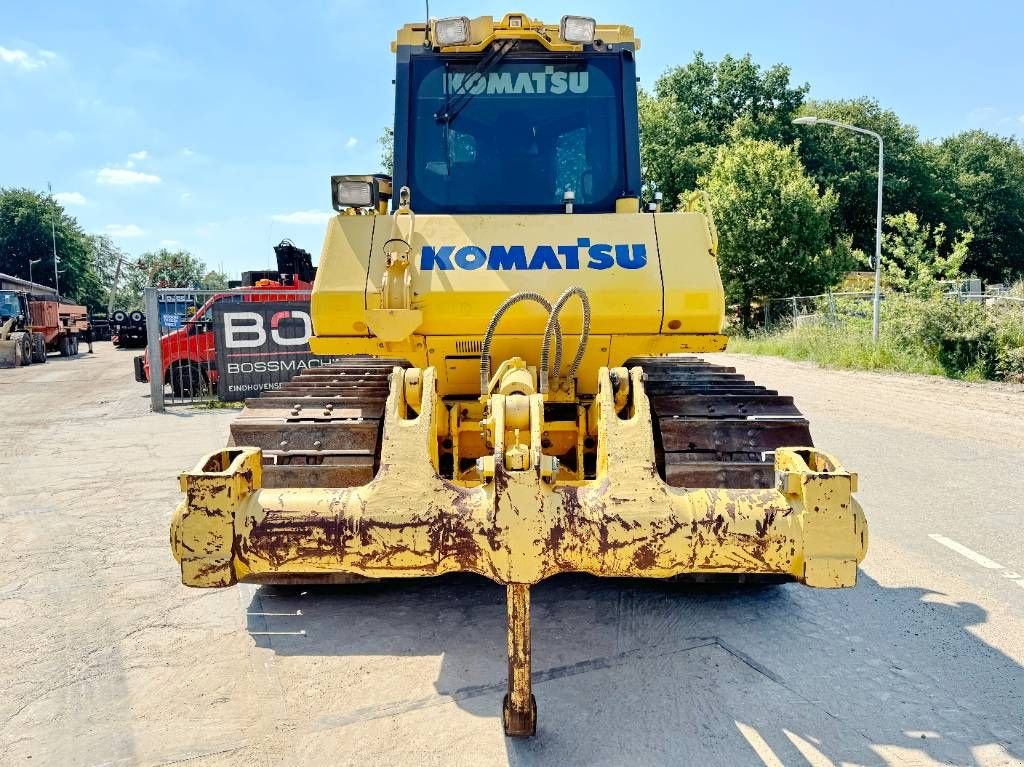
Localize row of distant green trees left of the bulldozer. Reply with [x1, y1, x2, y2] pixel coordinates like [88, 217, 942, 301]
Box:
[0, 188, 227, 312]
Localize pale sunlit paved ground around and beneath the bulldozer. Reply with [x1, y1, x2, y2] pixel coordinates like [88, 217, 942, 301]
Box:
[0, 343, 1024, 766]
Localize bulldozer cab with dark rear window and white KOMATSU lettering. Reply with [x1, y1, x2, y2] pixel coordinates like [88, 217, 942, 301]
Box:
[394, 14, 640, 214]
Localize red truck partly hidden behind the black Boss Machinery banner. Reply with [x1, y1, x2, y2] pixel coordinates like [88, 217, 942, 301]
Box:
[134, 240, 316, 398]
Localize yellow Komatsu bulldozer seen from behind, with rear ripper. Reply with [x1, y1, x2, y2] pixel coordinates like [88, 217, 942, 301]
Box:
[171, 13, 867, 735]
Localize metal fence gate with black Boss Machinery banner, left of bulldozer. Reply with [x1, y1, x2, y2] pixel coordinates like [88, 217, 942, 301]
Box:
[142, 287, 312, 413]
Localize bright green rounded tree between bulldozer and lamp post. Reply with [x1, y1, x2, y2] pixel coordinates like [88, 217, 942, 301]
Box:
[699, 138, 852, 328]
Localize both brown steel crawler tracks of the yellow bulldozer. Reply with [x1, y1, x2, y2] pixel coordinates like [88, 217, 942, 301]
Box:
[231, 357, 812, 488]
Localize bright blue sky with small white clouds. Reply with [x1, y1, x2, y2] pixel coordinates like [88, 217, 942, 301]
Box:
[0, 0, 1024, 274]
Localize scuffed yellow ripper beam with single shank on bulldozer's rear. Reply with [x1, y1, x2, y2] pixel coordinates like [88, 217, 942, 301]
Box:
[171, 368, 867, 735]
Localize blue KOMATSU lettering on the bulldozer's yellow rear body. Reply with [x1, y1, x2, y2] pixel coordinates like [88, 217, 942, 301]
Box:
[420, 242, 647, 271]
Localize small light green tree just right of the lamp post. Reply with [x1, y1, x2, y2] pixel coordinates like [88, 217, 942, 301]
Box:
[882, 212, 973, 295]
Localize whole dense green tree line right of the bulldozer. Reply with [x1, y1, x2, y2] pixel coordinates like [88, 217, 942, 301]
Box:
[640, 53, 1024, 325]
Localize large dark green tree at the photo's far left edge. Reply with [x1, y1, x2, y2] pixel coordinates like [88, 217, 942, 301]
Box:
[0, 188, 105, 309]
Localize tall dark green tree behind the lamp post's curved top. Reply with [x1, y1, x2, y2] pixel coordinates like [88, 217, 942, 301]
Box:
[799, 98, 951, 253]
